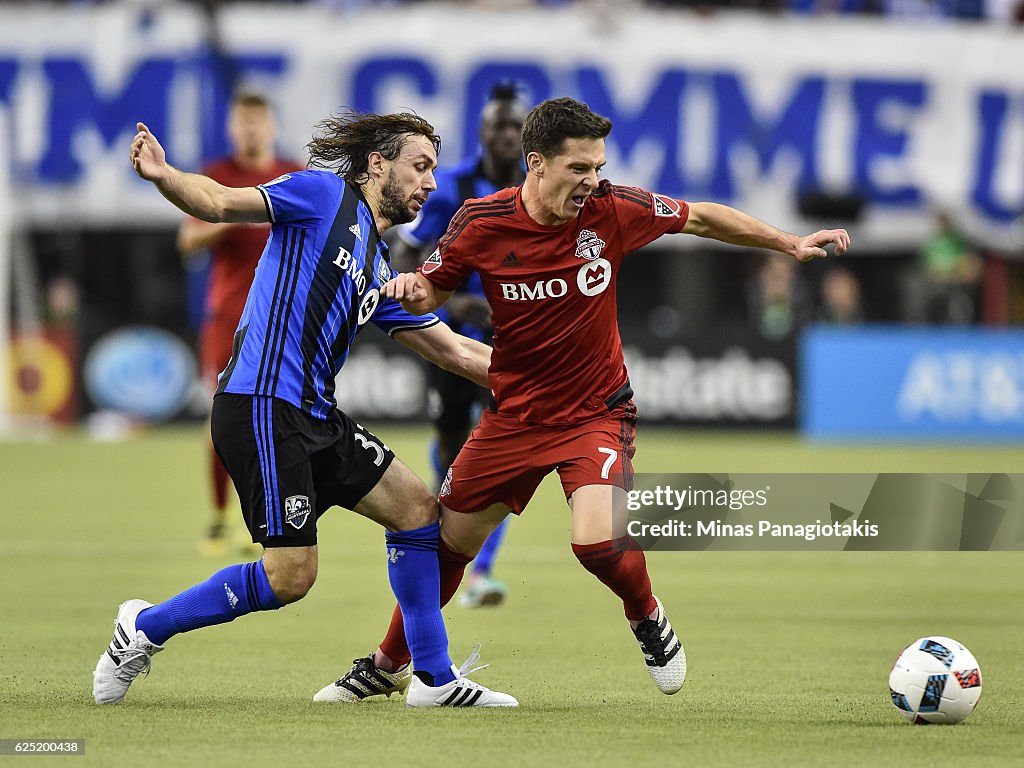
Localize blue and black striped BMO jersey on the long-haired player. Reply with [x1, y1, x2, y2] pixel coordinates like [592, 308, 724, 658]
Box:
[217, 171, 438, 419]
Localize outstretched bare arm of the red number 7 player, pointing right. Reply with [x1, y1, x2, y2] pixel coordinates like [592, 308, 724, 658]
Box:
[683, 203, 850, 261]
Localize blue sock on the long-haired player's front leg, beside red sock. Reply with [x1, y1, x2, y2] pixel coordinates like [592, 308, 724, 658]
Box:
[384, 522, 455, 686]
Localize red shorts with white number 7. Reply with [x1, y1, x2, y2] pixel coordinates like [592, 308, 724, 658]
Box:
[440, 400, 637, 515]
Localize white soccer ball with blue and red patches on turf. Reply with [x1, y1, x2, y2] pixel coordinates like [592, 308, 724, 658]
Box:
[889, 636, 981, 725]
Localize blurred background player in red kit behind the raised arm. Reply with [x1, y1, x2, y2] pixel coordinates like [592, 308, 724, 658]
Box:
[178, 92, 302, 554]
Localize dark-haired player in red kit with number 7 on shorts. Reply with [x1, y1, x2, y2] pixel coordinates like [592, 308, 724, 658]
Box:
[319, 98, 850, 693]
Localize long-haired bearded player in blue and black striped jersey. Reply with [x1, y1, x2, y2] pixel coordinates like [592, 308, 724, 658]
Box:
[93, 113, 517, 707]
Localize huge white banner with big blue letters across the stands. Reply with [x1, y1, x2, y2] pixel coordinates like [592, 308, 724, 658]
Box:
[0, 2, 1024, 248]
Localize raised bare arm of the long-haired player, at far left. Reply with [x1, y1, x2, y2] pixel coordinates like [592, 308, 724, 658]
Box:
[129, 123, 268, 222]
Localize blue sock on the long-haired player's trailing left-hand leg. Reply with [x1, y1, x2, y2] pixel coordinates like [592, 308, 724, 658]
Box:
[135, 560, 284, 645]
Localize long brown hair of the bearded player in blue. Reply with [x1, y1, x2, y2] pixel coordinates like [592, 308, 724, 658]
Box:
[306, 110, 441, 184]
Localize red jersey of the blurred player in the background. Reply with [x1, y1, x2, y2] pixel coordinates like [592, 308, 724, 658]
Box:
[203, 158, 302, 325]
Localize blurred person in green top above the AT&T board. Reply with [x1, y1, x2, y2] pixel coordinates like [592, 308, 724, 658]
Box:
[908, 211, 983, 325]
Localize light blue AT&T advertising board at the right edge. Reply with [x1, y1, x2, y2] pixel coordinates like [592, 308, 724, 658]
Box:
[800, 327, 1024, 442]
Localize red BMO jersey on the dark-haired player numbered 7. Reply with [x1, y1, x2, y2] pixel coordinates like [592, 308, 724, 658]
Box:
[420, 180, 689, 424]
